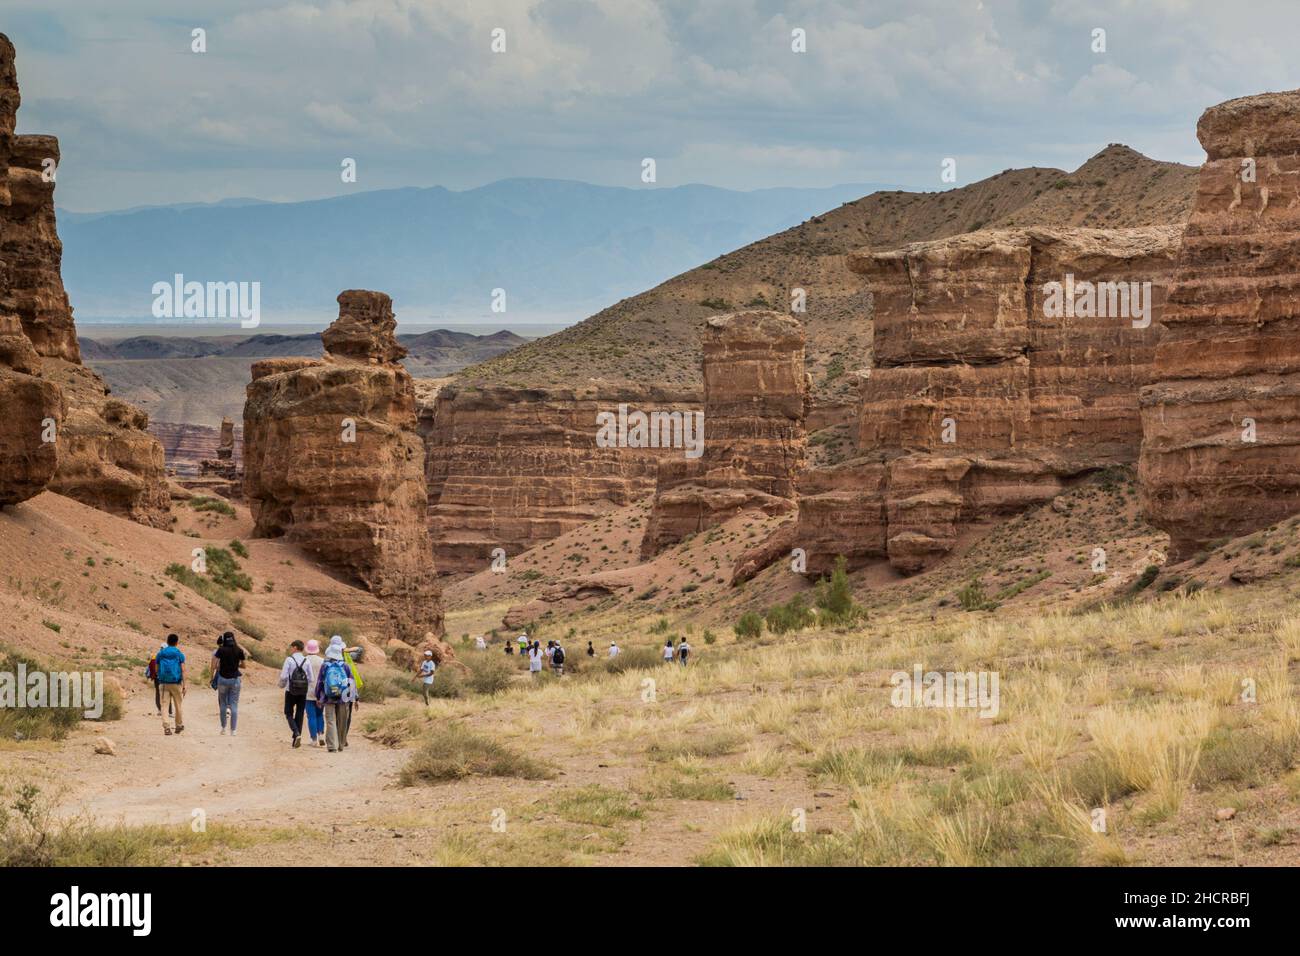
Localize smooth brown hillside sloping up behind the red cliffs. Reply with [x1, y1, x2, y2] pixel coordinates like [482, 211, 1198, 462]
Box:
[458, 146, 1195, 408]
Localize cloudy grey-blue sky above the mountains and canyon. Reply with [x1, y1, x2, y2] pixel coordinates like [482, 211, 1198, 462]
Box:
[0, 0, 1300, 211]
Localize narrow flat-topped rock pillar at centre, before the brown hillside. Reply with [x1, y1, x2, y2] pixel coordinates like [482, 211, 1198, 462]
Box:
[641, 311, 810, 558]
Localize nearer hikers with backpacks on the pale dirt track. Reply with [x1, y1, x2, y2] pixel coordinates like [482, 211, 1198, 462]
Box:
[146, 631, 369, 753]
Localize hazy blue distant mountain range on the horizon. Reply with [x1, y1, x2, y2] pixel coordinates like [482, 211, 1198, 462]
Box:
[59, 179, 880, 324]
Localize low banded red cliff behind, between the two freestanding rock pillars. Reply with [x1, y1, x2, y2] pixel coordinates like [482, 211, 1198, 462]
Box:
[421, 382, 699, 572]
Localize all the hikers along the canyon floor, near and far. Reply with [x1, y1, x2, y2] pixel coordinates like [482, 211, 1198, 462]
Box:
[146, 631, 690, 753]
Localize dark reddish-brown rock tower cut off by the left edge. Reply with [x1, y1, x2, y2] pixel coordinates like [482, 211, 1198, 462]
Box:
[0, 35, 170, 528]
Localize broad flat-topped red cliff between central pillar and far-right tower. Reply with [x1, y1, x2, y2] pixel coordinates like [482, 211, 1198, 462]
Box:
[794, 226, 1178, 572]
